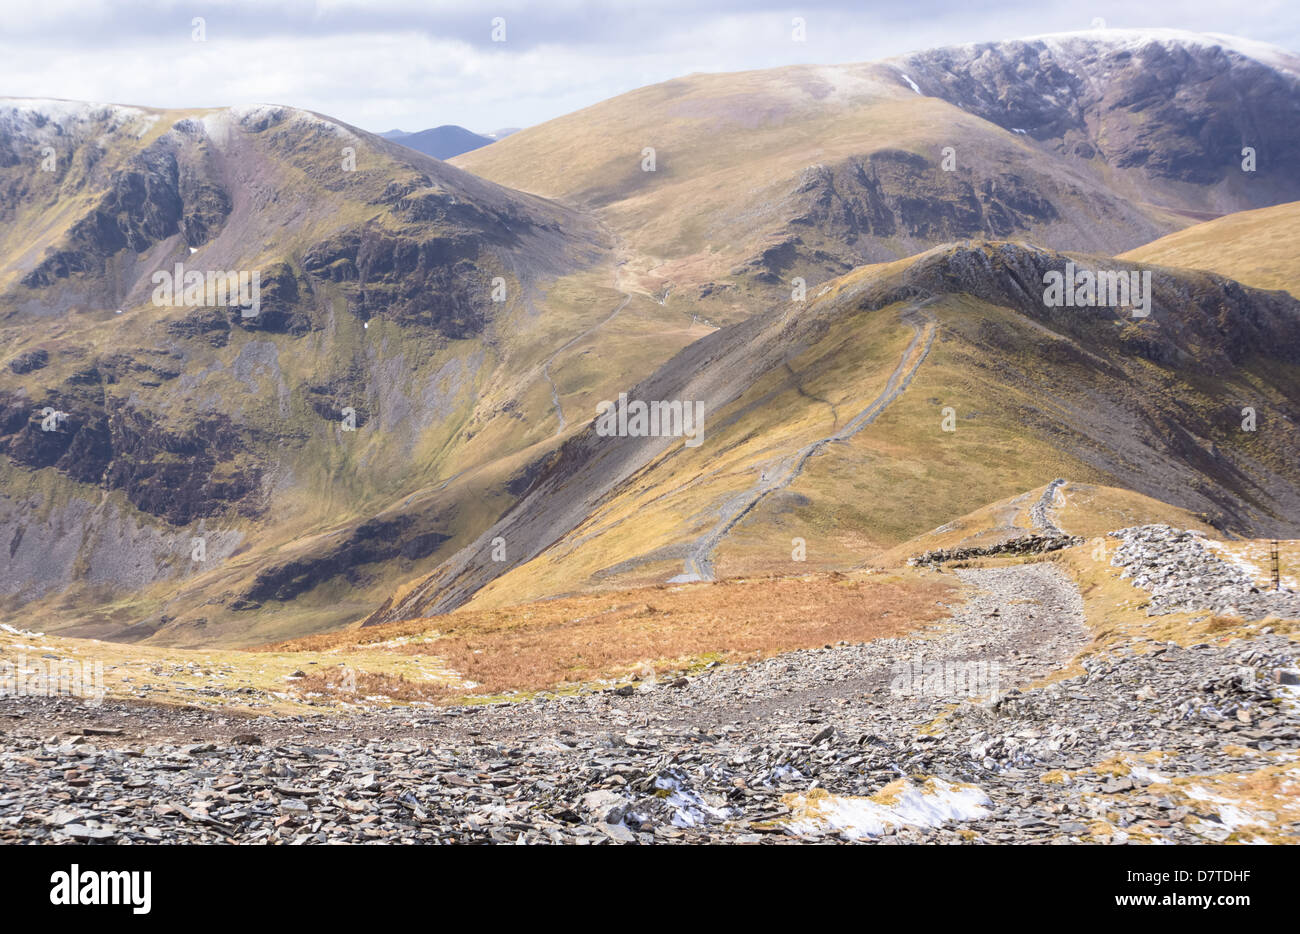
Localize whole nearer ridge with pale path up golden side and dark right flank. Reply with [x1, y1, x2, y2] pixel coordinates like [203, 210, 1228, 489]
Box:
[374, 243, 1300, 620]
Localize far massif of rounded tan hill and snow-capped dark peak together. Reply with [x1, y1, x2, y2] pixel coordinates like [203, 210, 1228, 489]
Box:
[455, 30, 1300, 323]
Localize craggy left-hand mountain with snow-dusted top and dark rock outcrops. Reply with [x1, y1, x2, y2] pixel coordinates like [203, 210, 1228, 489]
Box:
[0, 101, 709, 644]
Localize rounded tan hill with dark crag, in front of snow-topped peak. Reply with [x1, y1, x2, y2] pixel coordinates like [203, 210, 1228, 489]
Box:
[454, 65, 1170, 320]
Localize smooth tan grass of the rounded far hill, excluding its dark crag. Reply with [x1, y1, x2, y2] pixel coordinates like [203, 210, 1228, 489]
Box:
[452, 64, 1154, 324]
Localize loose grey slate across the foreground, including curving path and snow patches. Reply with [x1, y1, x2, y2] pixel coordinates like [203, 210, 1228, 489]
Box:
[0, 563, 1300, 843]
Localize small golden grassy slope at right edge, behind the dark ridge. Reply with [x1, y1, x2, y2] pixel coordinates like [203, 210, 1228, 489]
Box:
[1121, 202, 1300, 295]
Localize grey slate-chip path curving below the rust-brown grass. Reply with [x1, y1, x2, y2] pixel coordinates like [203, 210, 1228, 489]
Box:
[0, 563, 1086, 743]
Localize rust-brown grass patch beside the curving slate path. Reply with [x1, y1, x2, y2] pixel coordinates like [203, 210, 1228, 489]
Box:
[265, 572, 954, 696]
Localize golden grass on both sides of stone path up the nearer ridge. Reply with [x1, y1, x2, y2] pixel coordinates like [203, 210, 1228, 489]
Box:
[454, 297, 1096, 606]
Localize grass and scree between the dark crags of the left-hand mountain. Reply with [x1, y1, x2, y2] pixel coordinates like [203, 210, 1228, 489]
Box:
[0, 102, 709, 645]
